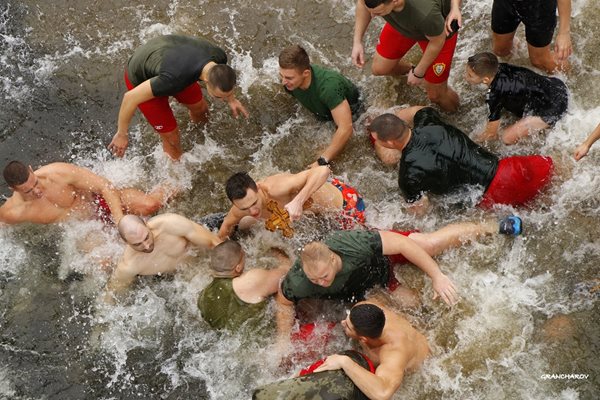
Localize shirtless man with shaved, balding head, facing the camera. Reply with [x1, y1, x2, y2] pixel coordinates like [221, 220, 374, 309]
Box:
[105, 213, 221, 302]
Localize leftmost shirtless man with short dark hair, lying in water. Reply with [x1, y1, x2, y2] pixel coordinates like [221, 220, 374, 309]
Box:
[0, 161, 166, 224]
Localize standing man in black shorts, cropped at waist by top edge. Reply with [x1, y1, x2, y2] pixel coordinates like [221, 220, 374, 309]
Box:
[492, 0, 572, 73]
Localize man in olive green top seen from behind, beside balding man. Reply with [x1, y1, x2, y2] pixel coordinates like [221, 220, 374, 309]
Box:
[198, 240, 289, 330]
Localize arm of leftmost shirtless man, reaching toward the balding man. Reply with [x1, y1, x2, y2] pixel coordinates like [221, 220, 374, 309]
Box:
[54, 163, 123, 224]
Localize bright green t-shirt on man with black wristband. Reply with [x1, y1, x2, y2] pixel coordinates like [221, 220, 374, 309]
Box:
[284, 64, 359, 121]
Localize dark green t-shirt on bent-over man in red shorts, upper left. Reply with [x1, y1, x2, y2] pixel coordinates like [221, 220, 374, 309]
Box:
[127, 35, 227, 97]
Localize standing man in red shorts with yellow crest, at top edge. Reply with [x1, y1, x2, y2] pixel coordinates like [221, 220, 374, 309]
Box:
[352, 0, 461, 111]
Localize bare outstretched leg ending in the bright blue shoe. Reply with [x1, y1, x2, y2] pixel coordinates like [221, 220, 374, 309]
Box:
[408, 220, 499, 257]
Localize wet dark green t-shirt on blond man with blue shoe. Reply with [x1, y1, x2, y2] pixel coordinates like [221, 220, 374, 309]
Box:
[281, 230, 390, 302]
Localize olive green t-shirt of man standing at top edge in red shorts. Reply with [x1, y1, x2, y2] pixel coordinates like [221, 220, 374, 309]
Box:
[383, 0, 450, 40]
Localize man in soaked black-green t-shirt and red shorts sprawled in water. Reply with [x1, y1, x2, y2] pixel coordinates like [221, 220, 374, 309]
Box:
[369, 106, 553, 212]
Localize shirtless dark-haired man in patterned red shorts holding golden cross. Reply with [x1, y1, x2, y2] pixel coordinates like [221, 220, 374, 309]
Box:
[219, 165, 365, 239]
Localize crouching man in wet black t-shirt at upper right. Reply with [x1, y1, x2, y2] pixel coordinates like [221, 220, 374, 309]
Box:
[465, 52, 569, 144]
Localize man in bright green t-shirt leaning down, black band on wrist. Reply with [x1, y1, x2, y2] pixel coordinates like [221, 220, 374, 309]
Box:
[279, 45, 360, 167]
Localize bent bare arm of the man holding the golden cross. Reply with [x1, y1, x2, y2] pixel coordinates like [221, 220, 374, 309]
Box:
[264, 165, 330, 221]
